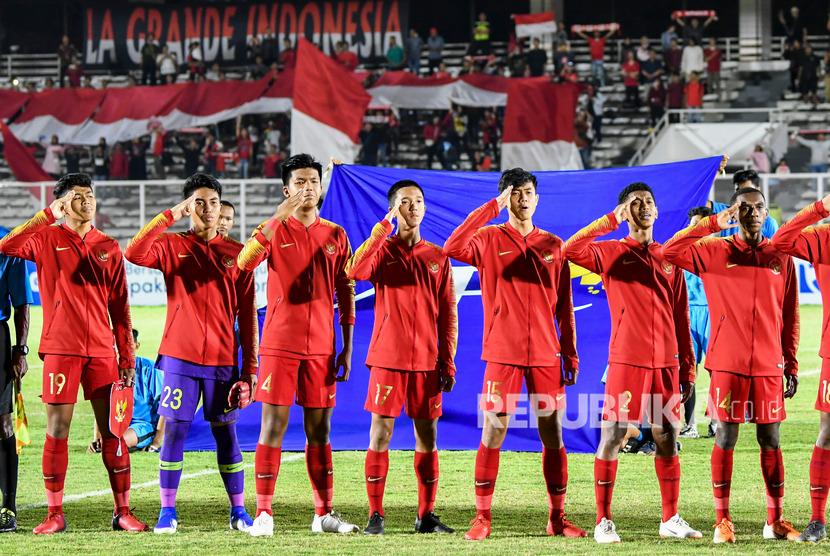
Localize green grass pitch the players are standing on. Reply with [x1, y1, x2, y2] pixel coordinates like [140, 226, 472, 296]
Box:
[0, 307, 830, 554]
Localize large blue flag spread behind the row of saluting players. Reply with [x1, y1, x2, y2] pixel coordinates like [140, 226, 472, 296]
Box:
[187, 156, 721, 452]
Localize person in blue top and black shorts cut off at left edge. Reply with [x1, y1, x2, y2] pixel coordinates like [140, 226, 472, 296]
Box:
[0, 222, 33, 533]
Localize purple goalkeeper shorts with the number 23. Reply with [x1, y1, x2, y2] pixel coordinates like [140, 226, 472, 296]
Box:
[159, 358, 239, 423]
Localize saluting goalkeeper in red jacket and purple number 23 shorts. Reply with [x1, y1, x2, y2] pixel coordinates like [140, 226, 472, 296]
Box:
[126, 174, 257, 534]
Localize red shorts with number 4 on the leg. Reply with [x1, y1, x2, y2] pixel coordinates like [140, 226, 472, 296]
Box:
[254, 355, 337, 407]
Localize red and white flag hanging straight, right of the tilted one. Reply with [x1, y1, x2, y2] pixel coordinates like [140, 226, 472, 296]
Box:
[501, 80, 582, 172]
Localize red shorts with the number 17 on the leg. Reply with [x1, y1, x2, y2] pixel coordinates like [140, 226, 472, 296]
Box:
[364, 367, 443, 419]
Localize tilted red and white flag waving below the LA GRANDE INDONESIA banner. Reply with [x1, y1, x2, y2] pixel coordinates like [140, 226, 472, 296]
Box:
[291, 38, 372, 166]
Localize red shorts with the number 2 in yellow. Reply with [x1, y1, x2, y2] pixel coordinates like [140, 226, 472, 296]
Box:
[602, 363, 682, 424]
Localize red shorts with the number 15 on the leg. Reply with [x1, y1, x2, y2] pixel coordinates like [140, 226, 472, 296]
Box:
[479, 362, 566, 414]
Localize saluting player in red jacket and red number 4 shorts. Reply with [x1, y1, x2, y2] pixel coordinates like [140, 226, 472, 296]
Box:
[237, 154, 358, 537]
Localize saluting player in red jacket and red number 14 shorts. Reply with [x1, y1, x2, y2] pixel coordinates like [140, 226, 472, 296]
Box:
[663, 187, 799, 543]
